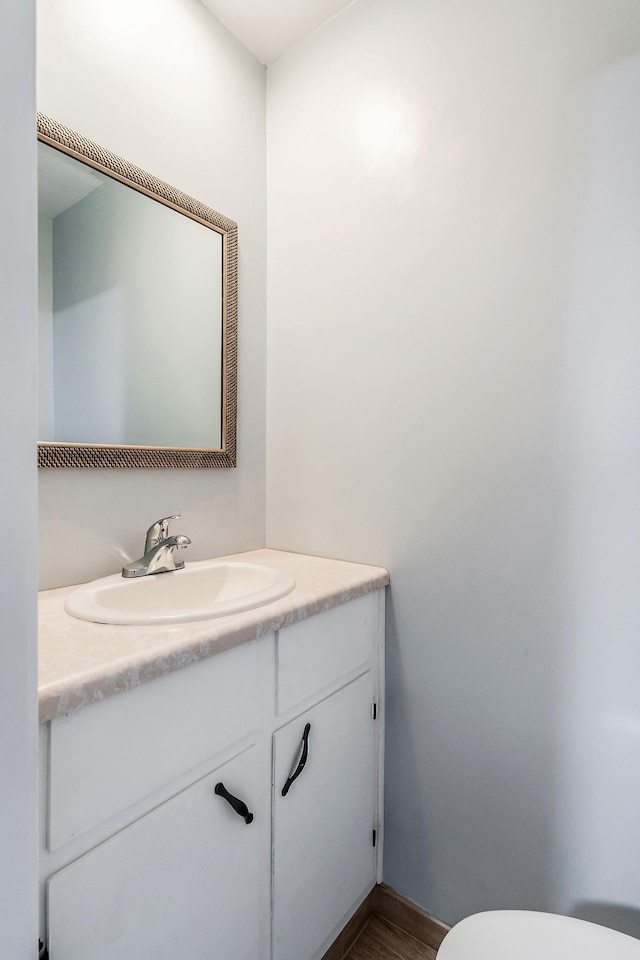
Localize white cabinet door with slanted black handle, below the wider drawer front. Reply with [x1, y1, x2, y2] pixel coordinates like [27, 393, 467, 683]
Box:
[48, 748, 262, 960]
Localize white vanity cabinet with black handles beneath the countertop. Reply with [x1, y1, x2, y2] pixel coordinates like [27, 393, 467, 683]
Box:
[42, 590, 384, 960]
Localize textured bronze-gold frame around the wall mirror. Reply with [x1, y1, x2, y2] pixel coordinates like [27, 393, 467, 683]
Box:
[38, 114, 238, 468]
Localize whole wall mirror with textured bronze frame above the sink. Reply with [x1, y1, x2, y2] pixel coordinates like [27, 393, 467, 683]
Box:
[38, 114, 238, 467]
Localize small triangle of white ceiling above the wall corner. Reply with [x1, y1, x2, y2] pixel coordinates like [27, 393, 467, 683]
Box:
[202, 0, 354, 64]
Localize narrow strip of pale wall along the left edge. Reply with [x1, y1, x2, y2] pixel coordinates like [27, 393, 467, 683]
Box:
[0, 0, 38, 960]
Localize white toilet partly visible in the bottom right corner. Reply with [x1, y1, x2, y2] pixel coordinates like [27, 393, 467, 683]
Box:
[438, 910, 640, 960]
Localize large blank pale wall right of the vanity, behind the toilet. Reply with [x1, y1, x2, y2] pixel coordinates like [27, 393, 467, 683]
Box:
[267, 0, 640, 935]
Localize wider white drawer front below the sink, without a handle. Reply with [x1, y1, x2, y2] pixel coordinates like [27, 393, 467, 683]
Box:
[48, 641, 258, 850]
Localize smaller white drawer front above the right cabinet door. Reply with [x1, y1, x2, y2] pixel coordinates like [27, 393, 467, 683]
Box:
[277, 592, 379, 713]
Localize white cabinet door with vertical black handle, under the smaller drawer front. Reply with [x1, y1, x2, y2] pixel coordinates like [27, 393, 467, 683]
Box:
[273, 673, 376, 960]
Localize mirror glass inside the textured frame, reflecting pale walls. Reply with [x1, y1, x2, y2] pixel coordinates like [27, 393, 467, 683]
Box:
[38, 143, 223, 449]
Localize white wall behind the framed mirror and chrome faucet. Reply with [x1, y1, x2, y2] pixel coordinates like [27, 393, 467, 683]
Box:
[37, 0, 266, 588]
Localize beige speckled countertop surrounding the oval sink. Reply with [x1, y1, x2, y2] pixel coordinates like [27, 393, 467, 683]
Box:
[38, 549, 389, 721]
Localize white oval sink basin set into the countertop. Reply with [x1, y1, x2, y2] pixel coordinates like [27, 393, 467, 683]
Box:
[65, 560, 296, 624]
